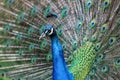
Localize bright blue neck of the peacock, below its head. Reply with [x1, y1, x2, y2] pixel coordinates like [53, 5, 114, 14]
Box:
[51, 35, 73, 80]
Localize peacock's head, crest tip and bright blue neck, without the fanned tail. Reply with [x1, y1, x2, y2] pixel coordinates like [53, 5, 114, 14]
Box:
[39, 24, 73, 80]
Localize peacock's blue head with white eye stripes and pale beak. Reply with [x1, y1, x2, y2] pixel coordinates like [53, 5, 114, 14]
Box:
[39, 25, 56, 39]
